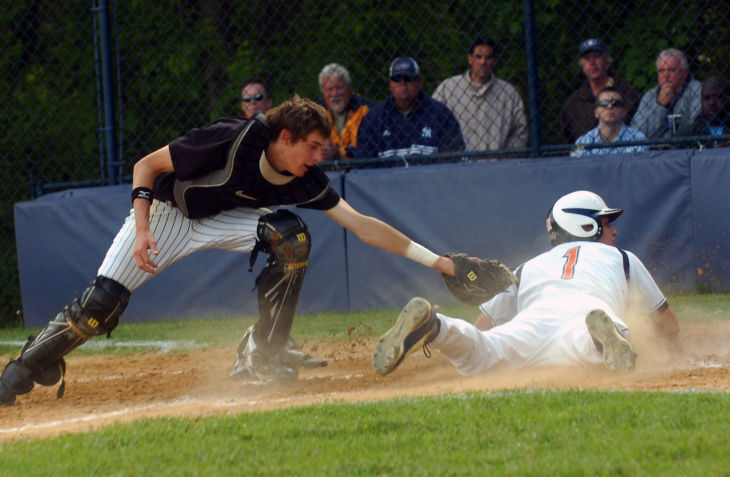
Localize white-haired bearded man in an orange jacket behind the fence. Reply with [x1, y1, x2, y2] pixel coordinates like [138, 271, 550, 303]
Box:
[319, 63, 372, 161]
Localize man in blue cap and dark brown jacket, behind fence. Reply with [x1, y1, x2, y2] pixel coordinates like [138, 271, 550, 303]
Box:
[559, 38, 641, 144]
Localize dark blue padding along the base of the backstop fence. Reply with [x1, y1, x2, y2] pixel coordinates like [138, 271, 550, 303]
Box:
[15, 149, 730, 326]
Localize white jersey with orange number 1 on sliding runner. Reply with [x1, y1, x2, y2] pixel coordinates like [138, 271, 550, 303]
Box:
[481, 242, 666, 324]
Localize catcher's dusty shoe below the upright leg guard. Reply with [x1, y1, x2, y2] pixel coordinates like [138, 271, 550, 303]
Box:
[230, 325, 299, 381]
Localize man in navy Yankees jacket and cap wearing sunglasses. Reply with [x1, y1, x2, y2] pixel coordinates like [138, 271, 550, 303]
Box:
[355, 56, 464, 158]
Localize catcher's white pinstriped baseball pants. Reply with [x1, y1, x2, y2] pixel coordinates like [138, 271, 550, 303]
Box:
[97, 200, 271, 292]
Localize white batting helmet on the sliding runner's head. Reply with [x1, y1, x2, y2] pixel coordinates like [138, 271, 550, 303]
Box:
[546, 190, 624, 246]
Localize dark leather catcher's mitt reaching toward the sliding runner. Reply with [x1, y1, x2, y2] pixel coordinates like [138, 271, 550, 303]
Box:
[441, 253, 517, 305]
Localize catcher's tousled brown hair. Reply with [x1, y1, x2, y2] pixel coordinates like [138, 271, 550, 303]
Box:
[265, 94, 332, 142]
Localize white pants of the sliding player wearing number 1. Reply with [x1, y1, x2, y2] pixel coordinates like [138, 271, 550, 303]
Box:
[431, 303, 629, 375]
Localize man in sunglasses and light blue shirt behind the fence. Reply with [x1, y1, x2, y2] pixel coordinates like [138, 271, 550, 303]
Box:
[571, 87, 649, 156]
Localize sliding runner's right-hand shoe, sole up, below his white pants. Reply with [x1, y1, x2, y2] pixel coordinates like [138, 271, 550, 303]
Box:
[586, 310, 636, 373]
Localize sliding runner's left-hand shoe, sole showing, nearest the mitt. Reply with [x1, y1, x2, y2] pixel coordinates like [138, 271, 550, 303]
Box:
[373, 297, 440, 375]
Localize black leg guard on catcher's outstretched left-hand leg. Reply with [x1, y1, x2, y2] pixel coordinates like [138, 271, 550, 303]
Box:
[0, 276, 130, 404]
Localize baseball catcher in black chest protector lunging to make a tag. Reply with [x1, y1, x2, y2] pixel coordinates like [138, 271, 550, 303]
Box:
[0, 96, 453, 406]
